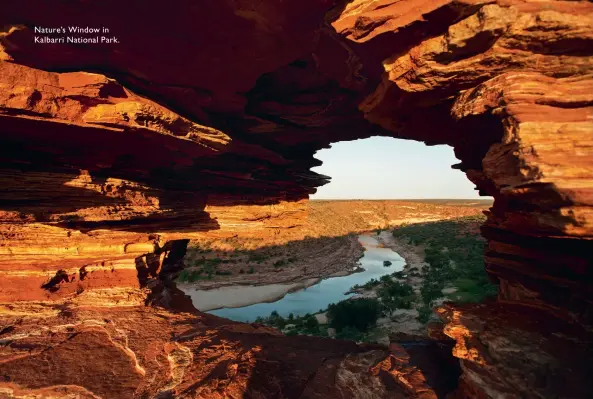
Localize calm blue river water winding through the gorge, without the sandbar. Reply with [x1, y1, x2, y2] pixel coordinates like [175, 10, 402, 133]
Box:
[194, 234, 405, 321]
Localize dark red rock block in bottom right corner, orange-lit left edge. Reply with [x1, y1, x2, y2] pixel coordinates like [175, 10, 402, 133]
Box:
[438, 303, 593, 398]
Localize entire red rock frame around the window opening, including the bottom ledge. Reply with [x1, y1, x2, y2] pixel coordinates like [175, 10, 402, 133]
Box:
[0, 0, 593, 398]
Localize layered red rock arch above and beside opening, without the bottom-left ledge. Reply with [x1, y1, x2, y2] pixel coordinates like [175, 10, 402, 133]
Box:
[0, 0, 593, 397]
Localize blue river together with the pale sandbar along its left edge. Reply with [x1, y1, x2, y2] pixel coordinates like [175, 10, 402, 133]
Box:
[186, 234, 405, 322]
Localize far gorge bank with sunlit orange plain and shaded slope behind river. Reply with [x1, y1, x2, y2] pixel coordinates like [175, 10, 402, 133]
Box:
[177, 200, 488, 290]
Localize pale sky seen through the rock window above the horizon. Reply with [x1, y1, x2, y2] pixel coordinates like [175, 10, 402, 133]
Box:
[311, 137, 487, 199]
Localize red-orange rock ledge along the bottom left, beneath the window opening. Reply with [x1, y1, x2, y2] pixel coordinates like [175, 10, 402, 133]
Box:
[0, 290, 436, 399]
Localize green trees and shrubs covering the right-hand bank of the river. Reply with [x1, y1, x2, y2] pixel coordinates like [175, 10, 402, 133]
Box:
[188, 212, 496, 342]
